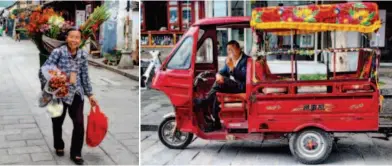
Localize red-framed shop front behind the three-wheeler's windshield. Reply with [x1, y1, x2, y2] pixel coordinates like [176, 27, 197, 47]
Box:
[140, 1, 205, 49]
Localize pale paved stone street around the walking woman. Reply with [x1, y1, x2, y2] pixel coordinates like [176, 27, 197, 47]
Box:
[0, 36, 139, 165]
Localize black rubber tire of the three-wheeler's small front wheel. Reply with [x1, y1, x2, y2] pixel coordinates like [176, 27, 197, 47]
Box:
[158, 117, 193, 149]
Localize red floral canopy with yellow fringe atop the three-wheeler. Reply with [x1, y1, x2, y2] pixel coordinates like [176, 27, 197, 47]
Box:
[250, 2, 381, 35]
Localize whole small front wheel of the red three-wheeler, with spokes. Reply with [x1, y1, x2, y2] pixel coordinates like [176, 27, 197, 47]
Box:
[158, 117, 193, 149]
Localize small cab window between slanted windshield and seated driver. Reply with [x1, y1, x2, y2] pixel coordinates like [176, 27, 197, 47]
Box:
[196, 38, 213, 63]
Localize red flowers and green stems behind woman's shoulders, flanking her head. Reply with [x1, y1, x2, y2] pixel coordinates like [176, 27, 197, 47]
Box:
[26, 6, 109, 65]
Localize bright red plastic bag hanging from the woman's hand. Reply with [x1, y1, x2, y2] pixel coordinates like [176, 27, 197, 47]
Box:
[86, 106, 108, 147]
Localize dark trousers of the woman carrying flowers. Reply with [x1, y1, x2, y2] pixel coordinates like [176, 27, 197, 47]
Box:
[52, 95, 84, 157]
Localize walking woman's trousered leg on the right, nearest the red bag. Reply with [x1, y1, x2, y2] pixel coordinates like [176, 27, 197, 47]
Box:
[69, 95, 84, 157]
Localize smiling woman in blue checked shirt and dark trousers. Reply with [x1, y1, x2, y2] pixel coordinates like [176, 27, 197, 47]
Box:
[39, 29, 97, 165]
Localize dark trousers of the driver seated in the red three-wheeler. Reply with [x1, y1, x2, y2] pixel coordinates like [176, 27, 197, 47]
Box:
[206, 77, 245, 124]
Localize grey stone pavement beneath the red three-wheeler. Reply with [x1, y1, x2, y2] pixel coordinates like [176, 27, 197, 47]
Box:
[140, 132, 392, 165]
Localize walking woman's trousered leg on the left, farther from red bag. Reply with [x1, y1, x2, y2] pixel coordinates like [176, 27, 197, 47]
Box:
[52, 103, 69, 150]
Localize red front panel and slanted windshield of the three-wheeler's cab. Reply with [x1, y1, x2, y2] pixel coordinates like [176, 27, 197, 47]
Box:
[153, 27, 199, 132]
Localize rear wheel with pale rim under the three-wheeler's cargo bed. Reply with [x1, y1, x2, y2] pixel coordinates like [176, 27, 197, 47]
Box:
[289, 129, 333, 164]
